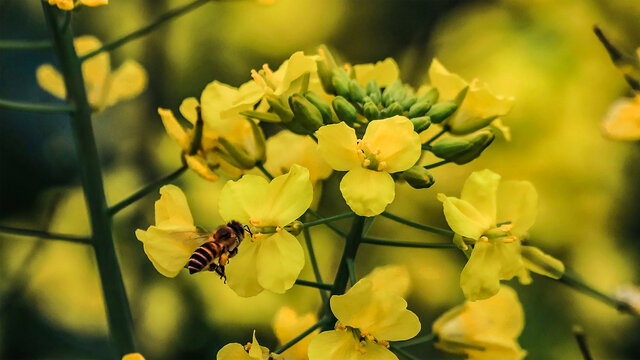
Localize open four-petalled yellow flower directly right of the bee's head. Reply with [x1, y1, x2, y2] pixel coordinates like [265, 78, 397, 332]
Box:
[218, 165, 313, 297]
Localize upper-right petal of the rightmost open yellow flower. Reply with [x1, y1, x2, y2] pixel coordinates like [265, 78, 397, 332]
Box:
[497, 180, 538, 238]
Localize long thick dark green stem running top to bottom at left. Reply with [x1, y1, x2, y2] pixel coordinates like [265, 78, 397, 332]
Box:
[42, 2, 136, 359]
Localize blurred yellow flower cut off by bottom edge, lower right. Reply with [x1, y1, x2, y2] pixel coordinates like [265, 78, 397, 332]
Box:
[432, 286, 526, 360]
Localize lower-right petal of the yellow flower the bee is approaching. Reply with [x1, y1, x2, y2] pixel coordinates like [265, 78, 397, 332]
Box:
[256, 230, 304, 294]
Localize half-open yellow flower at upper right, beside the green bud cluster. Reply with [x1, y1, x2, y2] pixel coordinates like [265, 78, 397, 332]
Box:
[429, 59, 513, 137]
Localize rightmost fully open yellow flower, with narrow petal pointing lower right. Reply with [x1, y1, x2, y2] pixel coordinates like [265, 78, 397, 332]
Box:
[438, 170, 564, 301]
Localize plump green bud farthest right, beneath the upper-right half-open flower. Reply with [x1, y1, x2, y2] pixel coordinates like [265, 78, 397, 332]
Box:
[431, 130, 495, 165]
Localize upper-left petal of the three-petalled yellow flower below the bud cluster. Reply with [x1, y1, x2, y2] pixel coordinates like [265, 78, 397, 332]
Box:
[315, 122, 361, 171]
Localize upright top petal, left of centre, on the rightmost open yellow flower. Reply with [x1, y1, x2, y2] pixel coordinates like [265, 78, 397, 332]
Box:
[460, 169, 500, 225]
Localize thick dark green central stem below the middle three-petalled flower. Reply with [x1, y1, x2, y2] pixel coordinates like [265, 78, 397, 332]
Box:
[323, 216, 366, 331]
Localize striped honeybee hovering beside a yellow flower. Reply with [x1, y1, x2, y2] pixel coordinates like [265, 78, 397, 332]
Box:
[185, 220, 251, 282]
